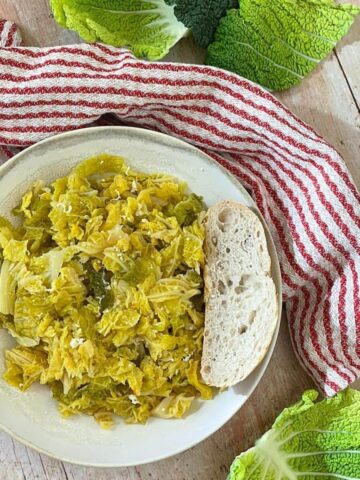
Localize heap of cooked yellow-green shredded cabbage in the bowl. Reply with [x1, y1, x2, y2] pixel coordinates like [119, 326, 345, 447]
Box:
[0, 154, 213, 428]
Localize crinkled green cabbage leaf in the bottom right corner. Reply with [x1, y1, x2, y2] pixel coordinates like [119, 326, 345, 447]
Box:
[228, 389, 360, 480]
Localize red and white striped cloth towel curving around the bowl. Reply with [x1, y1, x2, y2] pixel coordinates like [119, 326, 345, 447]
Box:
[0, 22, 360, 396]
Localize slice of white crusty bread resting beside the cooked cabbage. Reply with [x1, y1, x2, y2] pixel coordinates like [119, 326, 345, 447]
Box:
[201, 201, 278, 387]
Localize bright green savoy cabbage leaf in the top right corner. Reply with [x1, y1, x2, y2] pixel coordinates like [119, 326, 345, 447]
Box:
[206, 0, 360, 90]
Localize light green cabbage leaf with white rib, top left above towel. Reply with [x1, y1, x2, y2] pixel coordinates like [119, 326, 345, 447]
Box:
[50, 0, 188, 60]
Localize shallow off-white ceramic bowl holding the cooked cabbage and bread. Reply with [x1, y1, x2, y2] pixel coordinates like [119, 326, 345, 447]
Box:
[0, 127, 281, 467]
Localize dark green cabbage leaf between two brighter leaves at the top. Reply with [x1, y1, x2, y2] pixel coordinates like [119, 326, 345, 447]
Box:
[165, 0, 239, 48]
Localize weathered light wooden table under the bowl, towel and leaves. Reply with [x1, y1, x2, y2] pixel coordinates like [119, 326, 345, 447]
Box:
[0, 0, 360, 480]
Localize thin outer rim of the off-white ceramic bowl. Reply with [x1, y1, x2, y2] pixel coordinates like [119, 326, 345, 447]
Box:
[0, 126, 283, 468]
